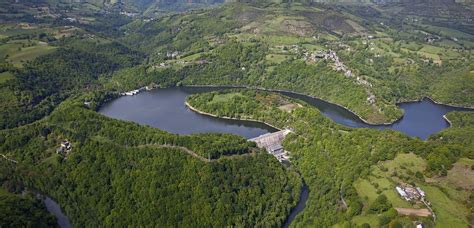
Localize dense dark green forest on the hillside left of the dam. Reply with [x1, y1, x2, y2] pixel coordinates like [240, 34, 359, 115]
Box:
[0, 95, 301, 226]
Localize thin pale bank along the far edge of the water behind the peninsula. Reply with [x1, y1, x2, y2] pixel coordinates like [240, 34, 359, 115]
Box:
[183, 85, 474, 126]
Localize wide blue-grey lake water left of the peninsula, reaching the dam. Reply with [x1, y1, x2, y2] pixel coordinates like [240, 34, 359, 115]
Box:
[99, 87, 276, 138]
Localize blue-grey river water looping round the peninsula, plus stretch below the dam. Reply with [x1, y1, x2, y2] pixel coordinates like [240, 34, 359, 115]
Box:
[99, 87, 472, 227]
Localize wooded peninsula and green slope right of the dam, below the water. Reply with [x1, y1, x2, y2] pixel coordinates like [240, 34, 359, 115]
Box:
[188, 89, 472, 226]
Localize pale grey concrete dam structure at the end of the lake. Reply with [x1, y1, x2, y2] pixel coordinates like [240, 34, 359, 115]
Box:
[250, 129, 291, 162]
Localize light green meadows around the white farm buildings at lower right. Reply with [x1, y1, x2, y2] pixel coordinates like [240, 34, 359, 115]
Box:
[352, 154, 473, 227]
